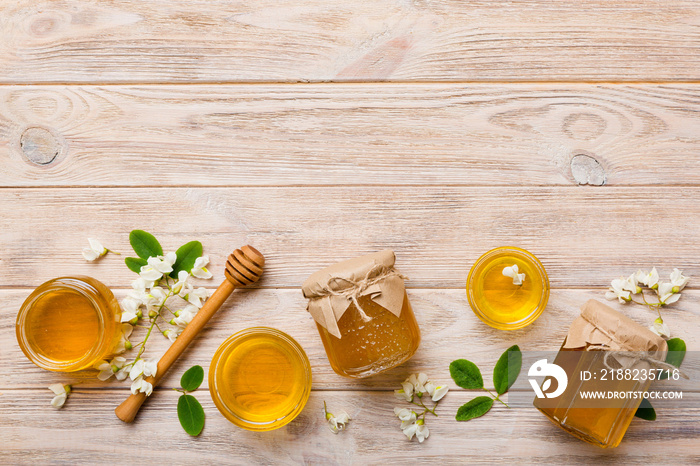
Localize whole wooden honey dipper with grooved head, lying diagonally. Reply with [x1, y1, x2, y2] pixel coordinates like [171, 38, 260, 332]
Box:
[114, 246, 265, 422]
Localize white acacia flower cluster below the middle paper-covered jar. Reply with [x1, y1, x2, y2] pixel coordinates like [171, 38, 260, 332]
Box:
[394, 372, 449, 443]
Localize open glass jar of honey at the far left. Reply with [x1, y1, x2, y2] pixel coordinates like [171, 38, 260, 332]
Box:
[16, 276, 122, 372]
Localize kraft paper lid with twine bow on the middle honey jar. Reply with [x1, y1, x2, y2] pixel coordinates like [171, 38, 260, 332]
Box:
[301, 249, 405, 338]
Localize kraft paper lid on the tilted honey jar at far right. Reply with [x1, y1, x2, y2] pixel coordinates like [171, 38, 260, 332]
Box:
[564, 299, 668, 357]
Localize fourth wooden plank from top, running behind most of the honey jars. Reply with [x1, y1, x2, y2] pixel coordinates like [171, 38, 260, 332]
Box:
[0, 289, 700, 390]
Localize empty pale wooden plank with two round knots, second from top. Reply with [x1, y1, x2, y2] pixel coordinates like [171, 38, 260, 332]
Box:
[0, 84, 700, 186]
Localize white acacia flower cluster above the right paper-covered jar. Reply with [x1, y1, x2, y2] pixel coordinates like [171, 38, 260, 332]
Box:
[605, 267, 690, 340]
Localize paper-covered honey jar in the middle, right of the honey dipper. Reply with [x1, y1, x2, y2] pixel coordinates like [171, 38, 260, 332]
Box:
[301, 250, 420, 378]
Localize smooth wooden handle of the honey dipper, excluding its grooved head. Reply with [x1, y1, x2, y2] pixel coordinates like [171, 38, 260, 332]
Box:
[114, 280, 235, 422]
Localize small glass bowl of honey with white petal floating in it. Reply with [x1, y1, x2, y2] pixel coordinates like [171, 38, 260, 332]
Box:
[467, 246, 549, 330]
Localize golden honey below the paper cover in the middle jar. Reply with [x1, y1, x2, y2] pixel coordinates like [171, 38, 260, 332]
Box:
[316, 293, 420, 377]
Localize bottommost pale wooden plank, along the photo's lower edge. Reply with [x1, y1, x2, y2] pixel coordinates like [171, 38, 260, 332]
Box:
[0, 388, 700, 464]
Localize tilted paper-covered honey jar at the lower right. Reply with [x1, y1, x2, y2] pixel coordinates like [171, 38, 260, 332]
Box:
[528, 300, 668, 448]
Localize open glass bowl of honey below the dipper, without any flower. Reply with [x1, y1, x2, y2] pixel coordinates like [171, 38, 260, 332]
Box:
[209, 327, 311, 431]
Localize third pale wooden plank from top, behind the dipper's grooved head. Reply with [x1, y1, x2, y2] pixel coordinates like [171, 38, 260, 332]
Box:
[0, 187, 700, 288]
